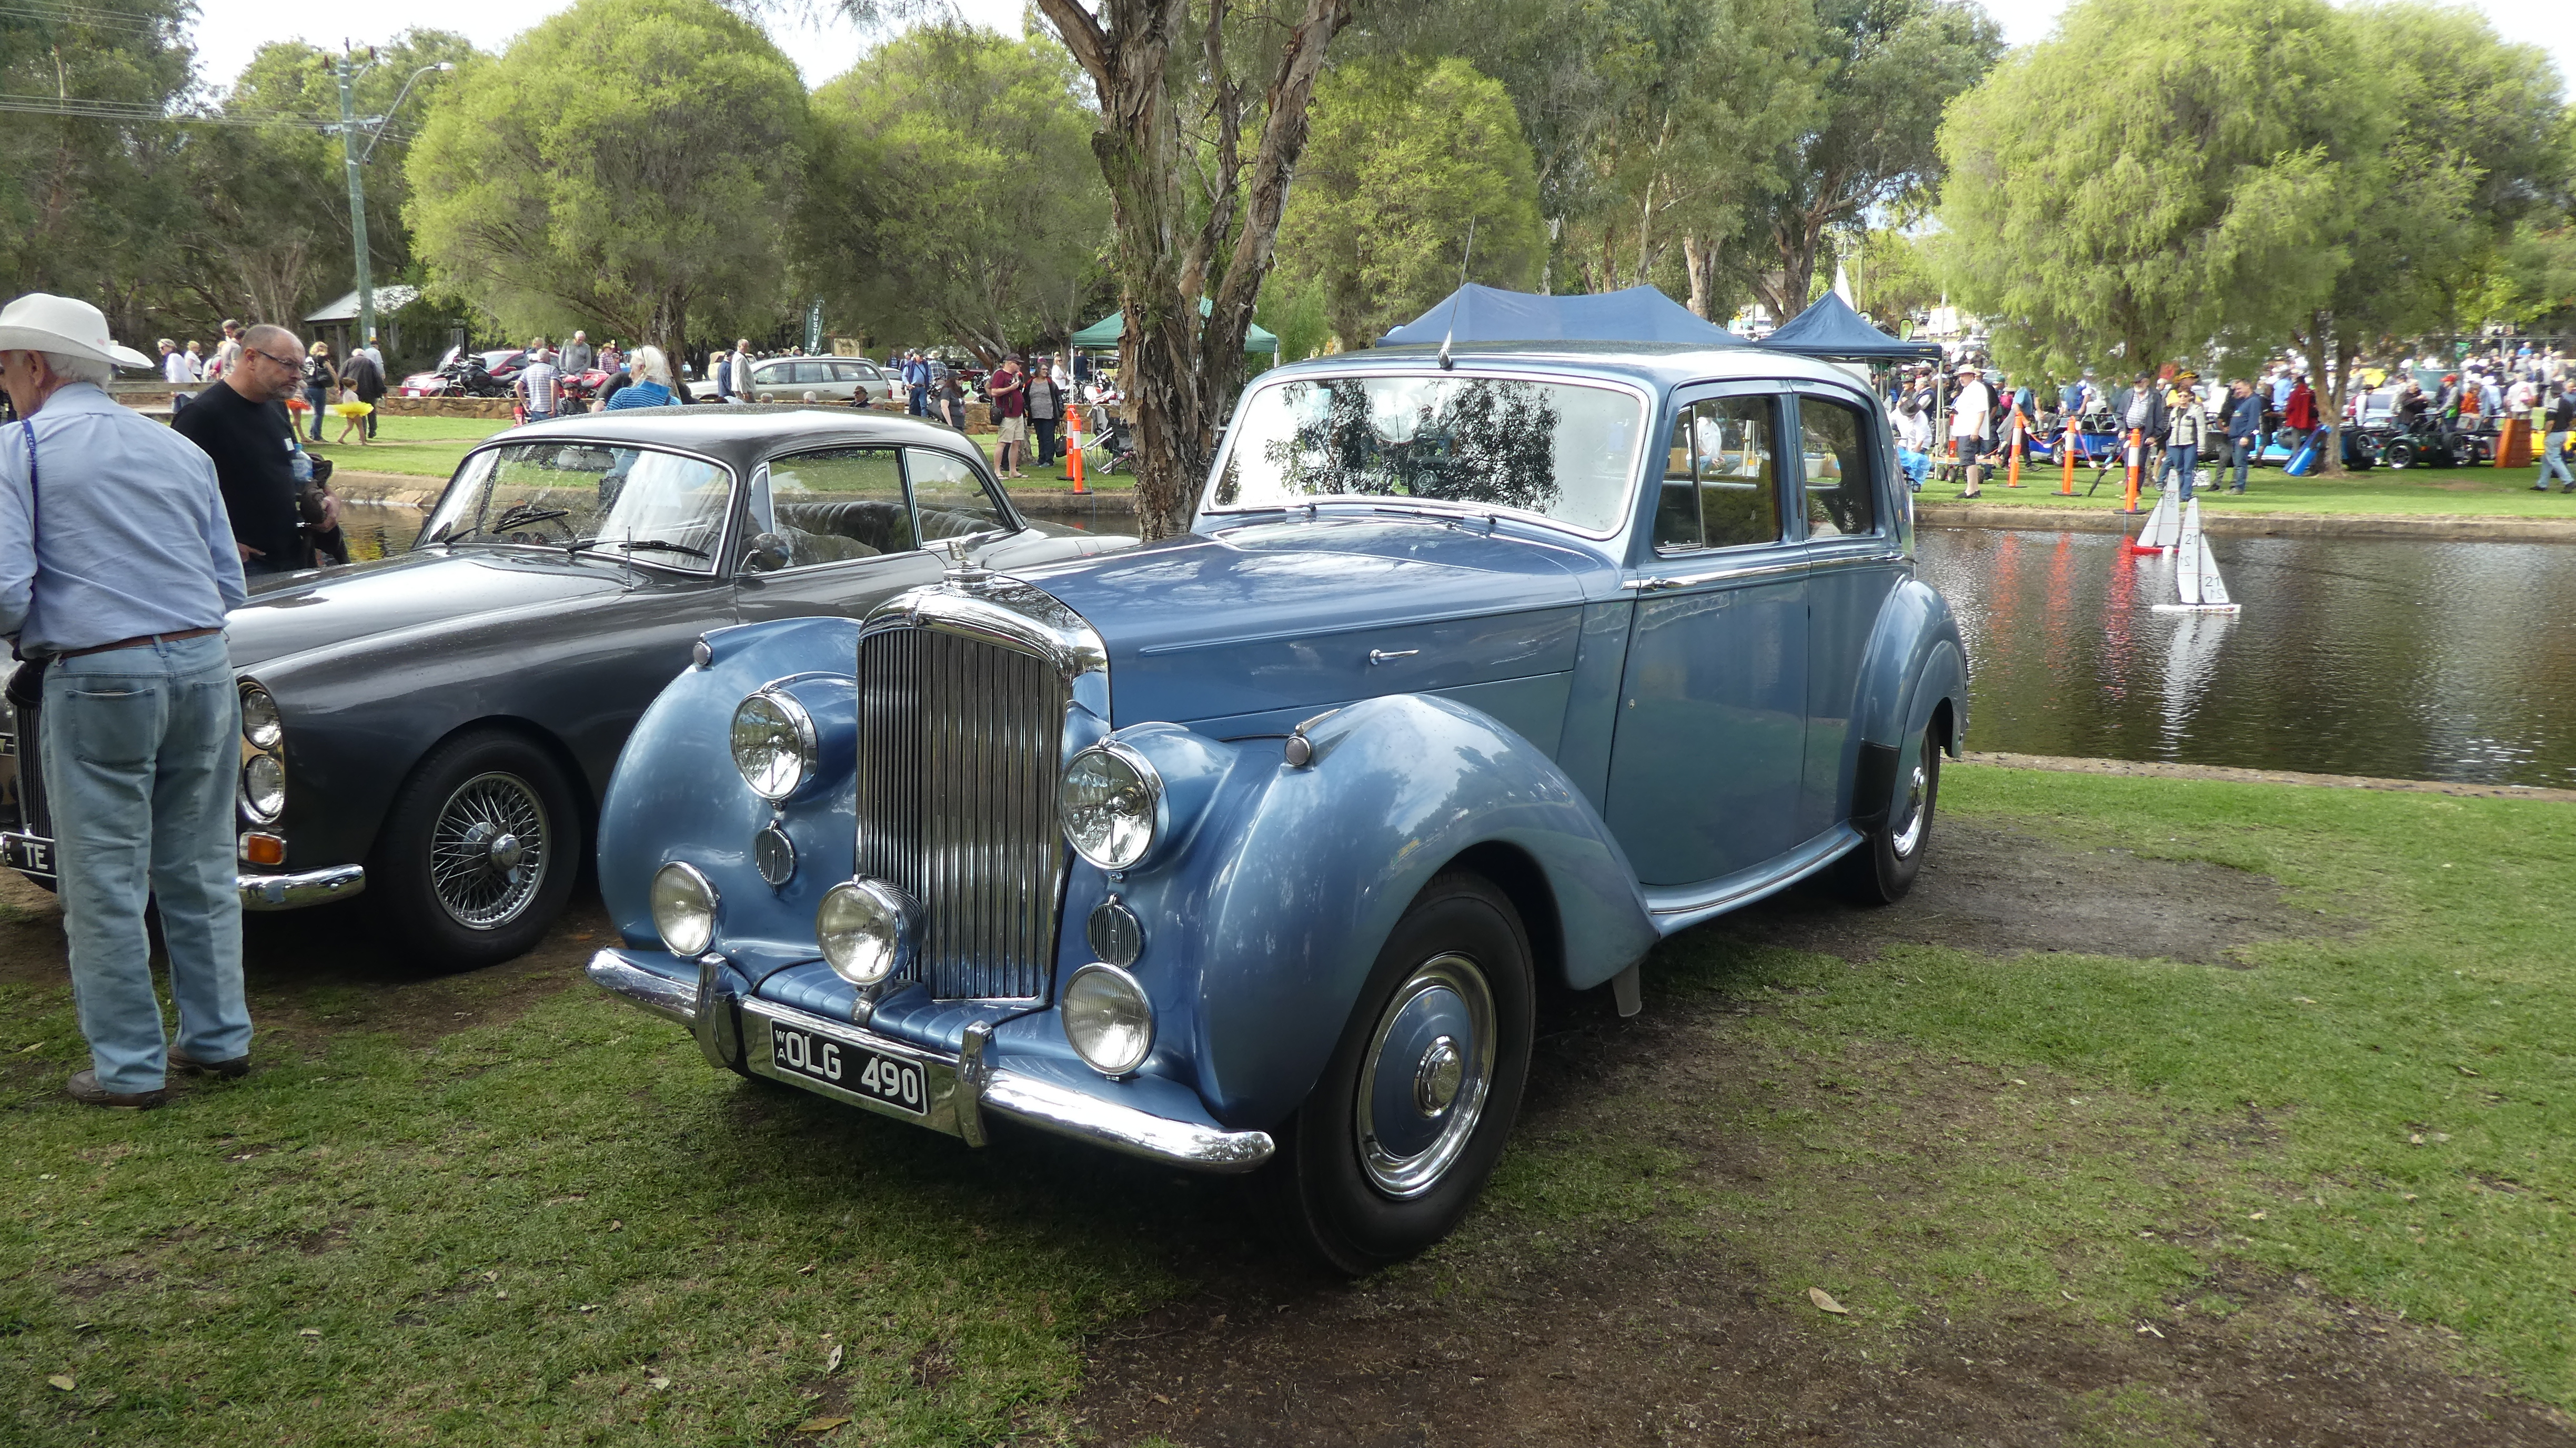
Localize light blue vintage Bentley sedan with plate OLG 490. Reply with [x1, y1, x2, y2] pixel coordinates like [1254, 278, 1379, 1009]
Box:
[590, 345, 1968, 1273]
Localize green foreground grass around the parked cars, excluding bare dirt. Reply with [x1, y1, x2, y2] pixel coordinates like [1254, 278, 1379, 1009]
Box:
[0, 768, 2576, 1445]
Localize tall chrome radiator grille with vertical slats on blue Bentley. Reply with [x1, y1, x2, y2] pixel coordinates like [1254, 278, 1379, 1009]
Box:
[858, 629, 1066, 1000]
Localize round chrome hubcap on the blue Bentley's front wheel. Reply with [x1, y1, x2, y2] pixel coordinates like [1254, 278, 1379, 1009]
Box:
[1355, 953, 1494, 1201]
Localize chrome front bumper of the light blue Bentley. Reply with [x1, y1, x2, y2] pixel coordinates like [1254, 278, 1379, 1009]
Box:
[585, 951, 1275, 1172]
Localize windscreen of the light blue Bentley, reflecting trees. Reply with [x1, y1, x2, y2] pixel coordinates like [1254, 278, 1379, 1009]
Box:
[1208, 374, 1646, 534]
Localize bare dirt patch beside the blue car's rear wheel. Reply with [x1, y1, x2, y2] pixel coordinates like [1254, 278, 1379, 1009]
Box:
[1723, 819, 2349, 966]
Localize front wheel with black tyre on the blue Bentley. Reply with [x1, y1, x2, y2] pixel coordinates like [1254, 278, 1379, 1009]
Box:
[1270, 871, 1535, 1275]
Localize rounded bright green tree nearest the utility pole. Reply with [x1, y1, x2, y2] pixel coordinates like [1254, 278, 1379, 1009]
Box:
[405, 0, 806, 345]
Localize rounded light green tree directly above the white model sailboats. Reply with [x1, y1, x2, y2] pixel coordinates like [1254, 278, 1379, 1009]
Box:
[1940, 0, 2388, 376]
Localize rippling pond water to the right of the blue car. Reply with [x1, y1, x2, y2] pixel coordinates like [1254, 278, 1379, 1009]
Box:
[1919, 528, 2576, 786]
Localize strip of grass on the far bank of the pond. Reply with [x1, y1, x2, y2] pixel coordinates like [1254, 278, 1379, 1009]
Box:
[1917, 456, 2576, 518]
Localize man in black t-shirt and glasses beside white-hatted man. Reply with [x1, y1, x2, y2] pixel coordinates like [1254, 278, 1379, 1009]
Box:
[170, 327, 340, 577]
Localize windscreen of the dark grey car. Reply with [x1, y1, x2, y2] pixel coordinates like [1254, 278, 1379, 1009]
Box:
[415, 443, 734, 572]
